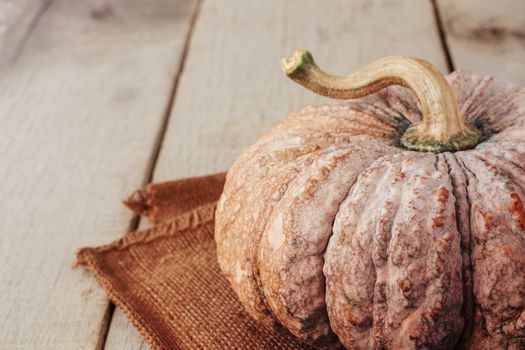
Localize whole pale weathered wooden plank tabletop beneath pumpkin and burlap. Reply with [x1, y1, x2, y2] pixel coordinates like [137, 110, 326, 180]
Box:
[0, 0, 525, 350]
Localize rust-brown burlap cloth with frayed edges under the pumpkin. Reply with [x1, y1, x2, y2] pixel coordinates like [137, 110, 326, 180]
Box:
[77, 174, 311, 349]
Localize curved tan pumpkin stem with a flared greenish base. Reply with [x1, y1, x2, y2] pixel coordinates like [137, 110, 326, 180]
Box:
[281, 49, 481, 152]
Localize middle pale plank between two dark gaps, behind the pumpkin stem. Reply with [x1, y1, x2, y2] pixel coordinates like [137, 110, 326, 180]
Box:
[106, 0, 446, 350]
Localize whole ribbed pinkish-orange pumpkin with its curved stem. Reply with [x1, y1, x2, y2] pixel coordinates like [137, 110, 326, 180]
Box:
[215, 50, 525, 349]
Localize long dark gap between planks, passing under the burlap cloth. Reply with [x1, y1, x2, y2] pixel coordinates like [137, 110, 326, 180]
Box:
[97, 0, 202, 350]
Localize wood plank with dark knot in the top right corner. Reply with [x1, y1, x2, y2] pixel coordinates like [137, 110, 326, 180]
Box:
[437, 0, 525, 85]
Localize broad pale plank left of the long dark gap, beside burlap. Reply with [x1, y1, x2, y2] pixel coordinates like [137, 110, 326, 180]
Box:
[0, 0, 196, 349]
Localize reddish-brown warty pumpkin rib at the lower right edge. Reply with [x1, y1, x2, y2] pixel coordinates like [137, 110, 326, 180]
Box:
[454, 154, 525, 349]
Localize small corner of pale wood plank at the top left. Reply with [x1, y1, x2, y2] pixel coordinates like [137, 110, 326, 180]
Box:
[0, 0, 52, 67]
